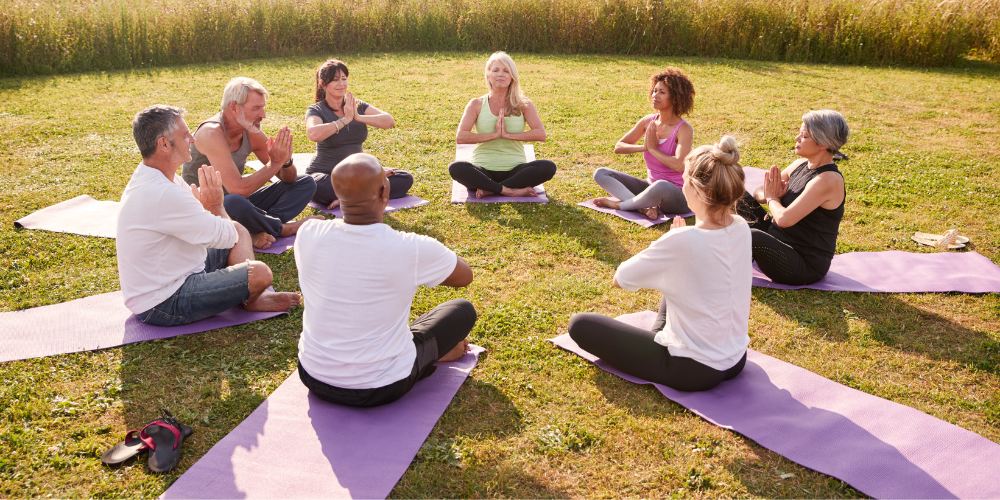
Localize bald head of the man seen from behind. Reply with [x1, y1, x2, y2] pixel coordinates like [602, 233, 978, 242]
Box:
[330, 153, 389, 223]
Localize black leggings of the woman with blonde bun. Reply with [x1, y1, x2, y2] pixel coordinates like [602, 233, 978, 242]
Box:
[569, 302, 747, 391]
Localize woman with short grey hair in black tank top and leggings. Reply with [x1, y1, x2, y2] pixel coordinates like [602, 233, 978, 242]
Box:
[737, 109, 849, 285]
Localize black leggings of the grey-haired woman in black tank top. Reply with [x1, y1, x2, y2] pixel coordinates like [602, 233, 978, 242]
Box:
[736, 193, 826, 285]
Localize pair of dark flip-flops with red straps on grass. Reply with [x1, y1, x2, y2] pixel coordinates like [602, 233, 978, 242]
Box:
[101, 410, 194, 472]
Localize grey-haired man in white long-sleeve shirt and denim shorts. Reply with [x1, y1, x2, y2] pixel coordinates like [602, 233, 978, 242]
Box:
[117, 105, 299, 326]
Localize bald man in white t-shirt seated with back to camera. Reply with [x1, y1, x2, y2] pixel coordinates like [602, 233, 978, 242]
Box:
[295, 153, 476, 406]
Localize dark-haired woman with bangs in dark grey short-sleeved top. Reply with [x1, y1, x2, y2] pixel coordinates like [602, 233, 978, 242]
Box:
[306, 59, 413, 209]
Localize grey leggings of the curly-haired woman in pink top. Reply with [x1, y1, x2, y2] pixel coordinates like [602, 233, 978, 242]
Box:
[594, 167, 691, 214]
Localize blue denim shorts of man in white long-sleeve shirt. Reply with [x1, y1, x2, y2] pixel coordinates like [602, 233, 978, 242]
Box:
[136, 248, 250, 326]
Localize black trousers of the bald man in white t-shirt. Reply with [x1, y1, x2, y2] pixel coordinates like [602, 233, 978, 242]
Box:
[299, 299, 476, 407]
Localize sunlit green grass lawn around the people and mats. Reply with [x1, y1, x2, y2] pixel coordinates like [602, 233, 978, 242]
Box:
[0, 53, 1000, 497]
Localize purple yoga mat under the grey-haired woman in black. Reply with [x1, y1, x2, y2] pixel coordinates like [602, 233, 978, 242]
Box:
[753, 250, 1000, 293]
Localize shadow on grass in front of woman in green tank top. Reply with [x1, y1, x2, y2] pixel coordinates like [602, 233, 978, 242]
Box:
[465, 194, 631, 266]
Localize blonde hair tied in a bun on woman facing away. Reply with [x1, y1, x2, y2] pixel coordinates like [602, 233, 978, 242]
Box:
[684, 135, 745, 216]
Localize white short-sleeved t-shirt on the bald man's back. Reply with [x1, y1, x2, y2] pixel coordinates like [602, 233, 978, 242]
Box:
[295, 219, 457, 388]
